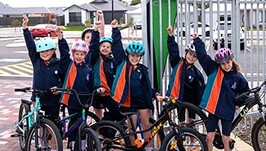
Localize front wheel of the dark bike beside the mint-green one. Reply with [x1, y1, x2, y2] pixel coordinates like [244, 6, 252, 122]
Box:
[74, 127, 102, 151]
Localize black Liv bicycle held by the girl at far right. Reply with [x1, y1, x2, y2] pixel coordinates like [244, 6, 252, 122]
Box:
[175, 80, 266, 151]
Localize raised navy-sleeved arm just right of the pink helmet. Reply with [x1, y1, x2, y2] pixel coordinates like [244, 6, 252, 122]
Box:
[89, 21, 102, 65]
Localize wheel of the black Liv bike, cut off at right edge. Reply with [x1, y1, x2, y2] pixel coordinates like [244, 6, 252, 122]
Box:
[251, 117, 266, 151]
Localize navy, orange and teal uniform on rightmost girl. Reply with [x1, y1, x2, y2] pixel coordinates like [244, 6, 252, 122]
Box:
[194, 38, 249, 135]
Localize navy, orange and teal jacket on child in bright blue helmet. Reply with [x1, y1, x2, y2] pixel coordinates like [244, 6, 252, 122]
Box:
[111, 29, 155, 111]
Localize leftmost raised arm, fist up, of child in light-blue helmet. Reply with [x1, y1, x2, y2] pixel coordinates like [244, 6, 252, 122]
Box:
[22, 16, 39, 63]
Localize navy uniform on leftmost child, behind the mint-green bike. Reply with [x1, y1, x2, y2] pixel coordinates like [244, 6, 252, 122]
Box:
[23, 28, 68, 121]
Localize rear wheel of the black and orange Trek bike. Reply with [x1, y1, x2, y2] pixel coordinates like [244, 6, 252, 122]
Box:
[91, 120, 130, 151]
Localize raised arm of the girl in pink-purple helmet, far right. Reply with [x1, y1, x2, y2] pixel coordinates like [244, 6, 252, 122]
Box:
[193, 33, 218, 76]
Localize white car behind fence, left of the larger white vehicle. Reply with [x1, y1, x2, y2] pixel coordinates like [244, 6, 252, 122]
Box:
[175, 22, 211, 37]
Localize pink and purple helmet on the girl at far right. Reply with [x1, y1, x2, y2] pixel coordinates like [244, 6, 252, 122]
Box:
[214, 48, 234, 63]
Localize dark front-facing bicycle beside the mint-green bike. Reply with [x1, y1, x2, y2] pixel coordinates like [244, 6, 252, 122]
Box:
[54, 88, 102, 151]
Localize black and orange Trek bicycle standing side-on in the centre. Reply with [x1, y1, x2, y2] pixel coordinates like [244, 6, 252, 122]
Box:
[92, 99, 207, 151]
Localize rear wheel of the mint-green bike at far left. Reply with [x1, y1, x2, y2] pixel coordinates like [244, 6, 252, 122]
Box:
[17, 104, 30, 151]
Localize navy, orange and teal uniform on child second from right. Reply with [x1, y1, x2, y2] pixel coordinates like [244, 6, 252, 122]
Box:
[166, 36, 205, 121]
